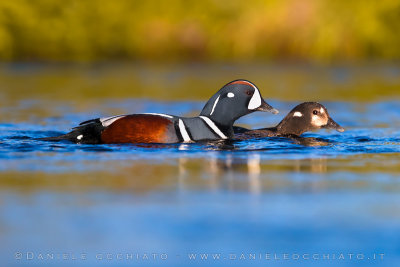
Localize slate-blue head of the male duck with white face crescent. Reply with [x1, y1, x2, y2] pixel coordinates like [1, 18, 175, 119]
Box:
[200, 80, 279, 126]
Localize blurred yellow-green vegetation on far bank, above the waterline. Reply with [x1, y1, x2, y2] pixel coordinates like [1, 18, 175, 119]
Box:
[0, 0, 400, 63]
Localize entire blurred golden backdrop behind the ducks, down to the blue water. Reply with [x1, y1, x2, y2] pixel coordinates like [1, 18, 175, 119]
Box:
[0, 0, 400, 106]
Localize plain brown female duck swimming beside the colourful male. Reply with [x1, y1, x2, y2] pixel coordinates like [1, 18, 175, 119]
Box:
[233, 102, 344, 140]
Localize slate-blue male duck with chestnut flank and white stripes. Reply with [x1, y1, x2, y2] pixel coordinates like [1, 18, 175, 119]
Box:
[41, 80, 278, 144]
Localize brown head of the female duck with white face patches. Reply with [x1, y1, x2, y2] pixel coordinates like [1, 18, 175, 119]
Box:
[277, 102, 344, 136]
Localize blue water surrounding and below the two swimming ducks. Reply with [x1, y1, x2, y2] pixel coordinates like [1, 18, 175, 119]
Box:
[0, 100, 400, 266]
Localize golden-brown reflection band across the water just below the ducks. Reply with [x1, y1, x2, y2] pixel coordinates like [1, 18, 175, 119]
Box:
[0, 152, 400, 194]
